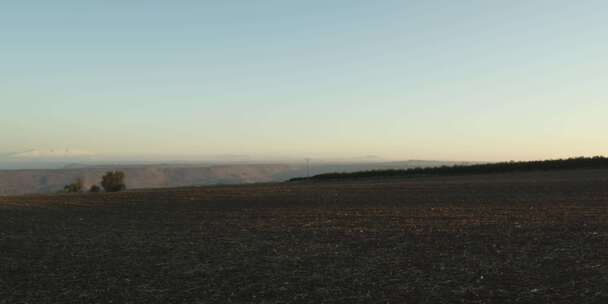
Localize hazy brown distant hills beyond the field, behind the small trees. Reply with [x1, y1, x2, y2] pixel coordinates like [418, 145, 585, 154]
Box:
[0, 160, 472, 195]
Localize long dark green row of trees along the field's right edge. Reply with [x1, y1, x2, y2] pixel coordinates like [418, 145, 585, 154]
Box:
[290, 156, 608, 181]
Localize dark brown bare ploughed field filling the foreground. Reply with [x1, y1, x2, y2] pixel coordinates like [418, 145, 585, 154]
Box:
[0, 170, 608, 304]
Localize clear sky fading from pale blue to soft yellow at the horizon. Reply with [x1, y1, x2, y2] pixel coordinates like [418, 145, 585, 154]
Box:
[0, 0, 608, 160]
